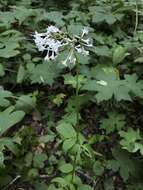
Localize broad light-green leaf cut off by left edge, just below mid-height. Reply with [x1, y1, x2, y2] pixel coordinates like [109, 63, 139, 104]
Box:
[0, 106, 25, 135]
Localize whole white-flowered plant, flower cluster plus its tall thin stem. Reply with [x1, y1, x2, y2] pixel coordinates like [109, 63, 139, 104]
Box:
[34, 26, 92, 181]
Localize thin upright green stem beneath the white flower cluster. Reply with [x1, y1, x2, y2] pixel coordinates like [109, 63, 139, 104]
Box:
[72, 53, 80, 182]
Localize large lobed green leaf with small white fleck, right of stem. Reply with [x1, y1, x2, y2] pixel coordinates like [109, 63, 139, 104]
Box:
[82, 67, 131, 102]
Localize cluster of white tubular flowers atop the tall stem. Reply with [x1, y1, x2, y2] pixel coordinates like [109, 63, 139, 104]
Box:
[34, 25, 92, 65]
